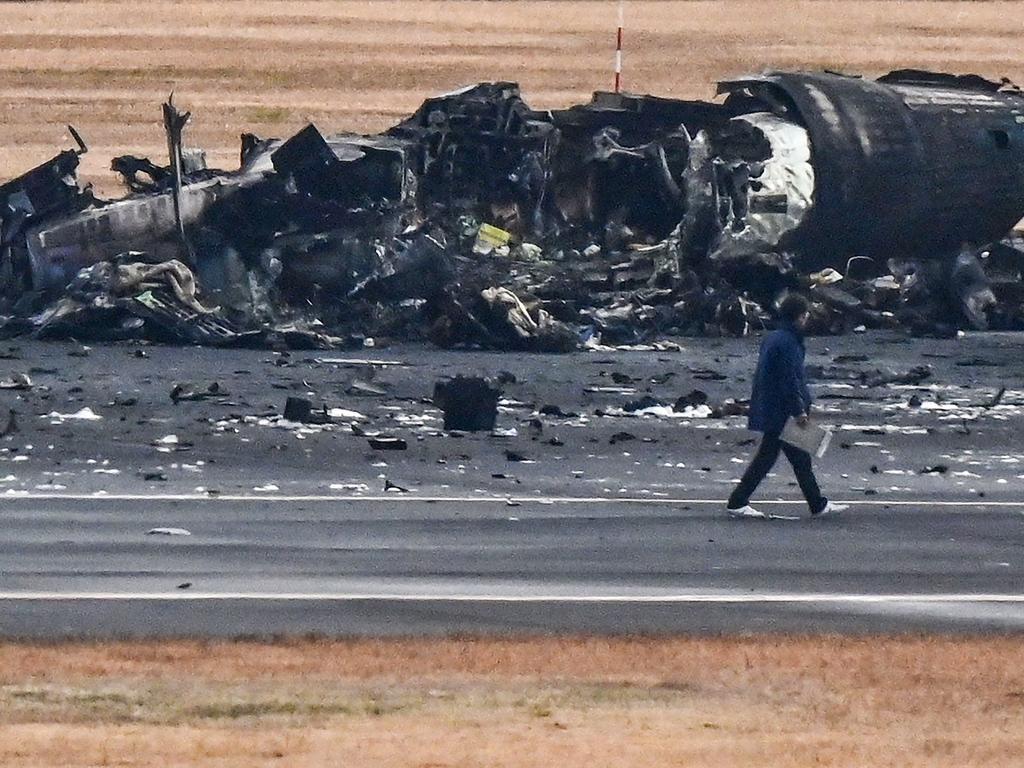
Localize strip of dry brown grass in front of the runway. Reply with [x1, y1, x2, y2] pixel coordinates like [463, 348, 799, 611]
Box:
[0, 638, 1024, 768]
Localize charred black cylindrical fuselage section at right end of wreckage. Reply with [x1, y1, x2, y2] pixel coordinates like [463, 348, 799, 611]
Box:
[721, 72, 1024, 265]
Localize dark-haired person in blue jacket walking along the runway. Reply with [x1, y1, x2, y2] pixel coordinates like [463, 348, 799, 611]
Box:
[727, 294, 847, 518]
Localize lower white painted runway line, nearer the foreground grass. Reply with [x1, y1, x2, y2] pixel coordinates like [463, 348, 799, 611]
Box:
[0, 592, 1024, 605]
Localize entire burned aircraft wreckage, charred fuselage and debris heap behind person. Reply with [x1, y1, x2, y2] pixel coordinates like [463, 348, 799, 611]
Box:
[0, 71, 1024, 351]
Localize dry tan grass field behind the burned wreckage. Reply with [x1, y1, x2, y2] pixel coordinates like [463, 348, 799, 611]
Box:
[0, 0, 1024, 193]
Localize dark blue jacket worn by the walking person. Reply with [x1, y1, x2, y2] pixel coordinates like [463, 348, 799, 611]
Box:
[746, 325, 811, 433]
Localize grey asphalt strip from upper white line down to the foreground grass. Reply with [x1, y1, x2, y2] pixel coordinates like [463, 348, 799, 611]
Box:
[0, 494, 1024, 639]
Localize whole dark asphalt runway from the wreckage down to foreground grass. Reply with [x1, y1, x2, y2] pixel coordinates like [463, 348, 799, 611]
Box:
[0, 334, 1024, 638]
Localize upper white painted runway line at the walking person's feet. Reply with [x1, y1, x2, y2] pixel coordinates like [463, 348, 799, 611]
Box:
[0, 494, 1024, 509]
